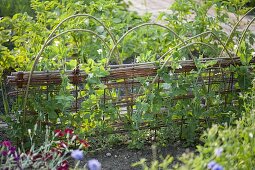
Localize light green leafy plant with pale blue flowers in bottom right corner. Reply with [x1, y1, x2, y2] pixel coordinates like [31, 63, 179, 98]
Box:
[134, 81, 255, 170]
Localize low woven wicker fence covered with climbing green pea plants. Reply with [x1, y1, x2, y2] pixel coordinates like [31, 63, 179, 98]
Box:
[5, 58, 255, 136]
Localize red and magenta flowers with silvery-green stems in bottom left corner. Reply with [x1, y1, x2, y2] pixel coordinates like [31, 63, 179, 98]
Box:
[0, 126, 89, 170]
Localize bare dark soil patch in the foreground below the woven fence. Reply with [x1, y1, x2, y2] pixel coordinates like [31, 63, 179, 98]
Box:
[72, 142, 191, 170]
